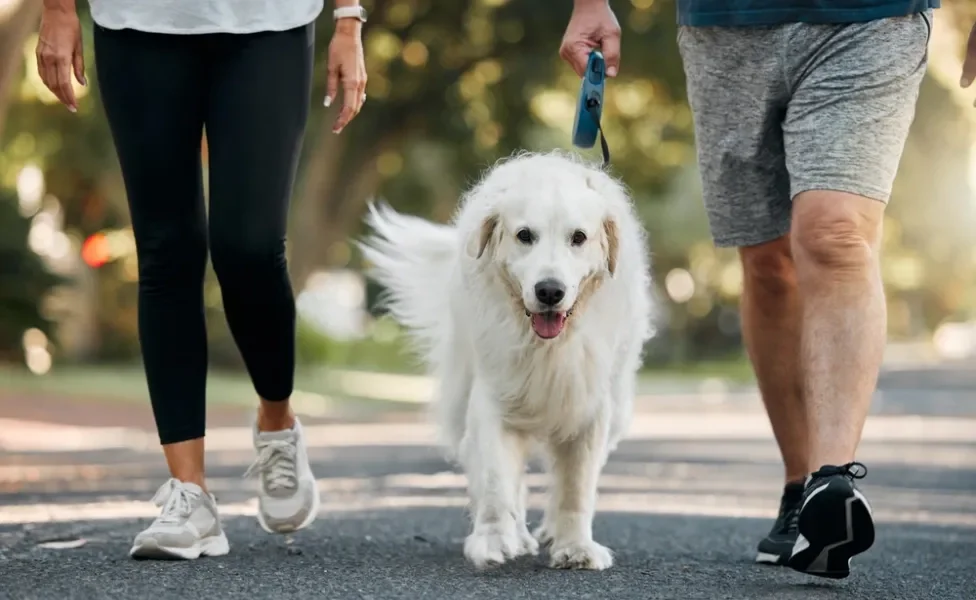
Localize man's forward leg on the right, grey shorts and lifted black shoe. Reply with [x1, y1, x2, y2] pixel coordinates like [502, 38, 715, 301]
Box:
[783, 7, 931, 578]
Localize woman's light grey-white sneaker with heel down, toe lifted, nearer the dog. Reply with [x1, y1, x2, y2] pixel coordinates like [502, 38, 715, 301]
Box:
[244, 418, 319, 533]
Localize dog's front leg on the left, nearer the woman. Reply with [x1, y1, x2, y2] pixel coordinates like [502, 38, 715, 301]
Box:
[462, 378, 538, 569]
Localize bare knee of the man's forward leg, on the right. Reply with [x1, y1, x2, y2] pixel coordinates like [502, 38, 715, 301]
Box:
[791, 191, 884, 277]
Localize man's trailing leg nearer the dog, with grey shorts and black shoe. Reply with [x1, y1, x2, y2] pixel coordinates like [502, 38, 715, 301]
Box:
[678, 27, 808, 565]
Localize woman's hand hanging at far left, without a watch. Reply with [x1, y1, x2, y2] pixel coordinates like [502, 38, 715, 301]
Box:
[36, 0, 88, 112]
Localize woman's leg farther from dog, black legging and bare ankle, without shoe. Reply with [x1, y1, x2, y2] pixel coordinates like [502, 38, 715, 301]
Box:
[95, 26, 207, 487]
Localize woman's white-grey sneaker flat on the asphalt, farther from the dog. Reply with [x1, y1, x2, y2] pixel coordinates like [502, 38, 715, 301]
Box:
[129, 479, 230, 560]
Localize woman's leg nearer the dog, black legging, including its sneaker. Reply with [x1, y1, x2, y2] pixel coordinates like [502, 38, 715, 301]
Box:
[206, 24, 318, 532]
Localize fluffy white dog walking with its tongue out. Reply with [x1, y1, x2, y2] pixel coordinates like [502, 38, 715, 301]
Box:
[360, 153, 652, 570]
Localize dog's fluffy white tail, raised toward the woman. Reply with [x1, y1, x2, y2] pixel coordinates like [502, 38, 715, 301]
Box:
[358, 204, 457, 371]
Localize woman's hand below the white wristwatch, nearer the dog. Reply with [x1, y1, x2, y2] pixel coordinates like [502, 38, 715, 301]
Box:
[325, 19, 366, 133]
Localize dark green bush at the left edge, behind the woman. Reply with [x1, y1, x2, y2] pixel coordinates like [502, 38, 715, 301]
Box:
[0, 188, 65, 361]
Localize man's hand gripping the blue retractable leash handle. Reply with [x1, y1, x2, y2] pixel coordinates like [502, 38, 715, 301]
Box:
[559, 0, 620, 77]
